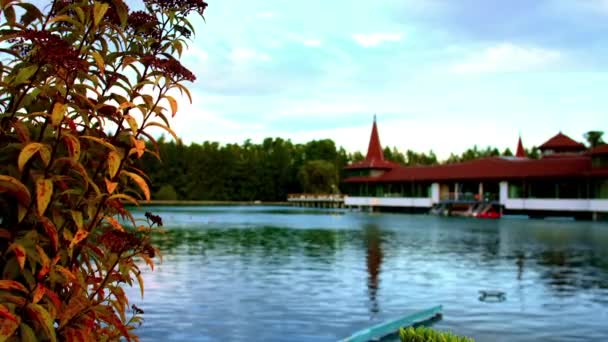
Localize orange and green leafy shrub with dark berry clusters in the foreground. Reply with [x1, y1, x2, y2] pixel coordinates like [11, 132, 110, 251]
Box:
[0, 0, 207, 341]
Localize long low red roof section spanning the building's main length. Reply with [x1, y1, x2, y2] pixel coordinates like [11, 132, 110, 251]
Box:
[345, 156, 591, 183]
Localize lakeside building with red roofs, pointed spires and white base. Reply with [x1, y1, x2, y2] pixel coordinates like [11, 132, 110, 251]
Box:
[344, 118, 608, 217]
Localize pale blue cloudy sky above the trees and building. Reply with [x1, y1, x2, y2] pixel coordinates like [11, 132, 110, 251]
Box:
[167, 0, 608, 158]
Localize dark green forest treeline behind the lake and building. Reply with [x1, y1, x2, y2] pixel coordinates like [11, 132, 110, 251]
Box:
[140, 137, 538, 201]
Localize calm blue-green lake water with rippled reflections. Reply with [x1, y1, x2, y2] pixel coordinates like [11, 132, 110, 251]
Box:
[123, 207, 608, 341]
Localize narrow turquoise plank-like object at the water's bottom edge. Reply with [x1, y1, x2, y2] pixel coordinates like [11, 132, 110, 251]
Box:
[341, 305, 443, 342]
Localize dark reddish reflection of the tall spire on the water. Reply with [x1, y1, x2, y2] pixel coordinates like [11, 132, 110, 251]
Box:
[364, 225, 383, 317]
